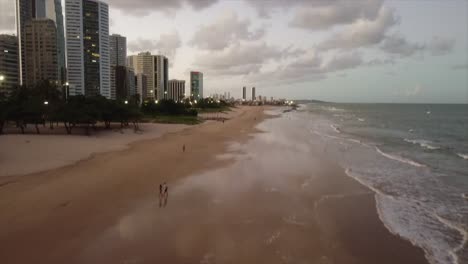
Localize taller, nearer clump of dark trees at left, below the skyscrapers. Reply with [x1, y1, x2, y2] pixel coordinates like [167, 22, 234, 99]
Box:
[0, 82, 143, 134]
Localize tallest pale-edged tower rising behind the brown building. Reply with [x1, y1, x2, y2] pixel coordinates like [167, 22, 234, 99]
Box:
[16, 0, 66, 84]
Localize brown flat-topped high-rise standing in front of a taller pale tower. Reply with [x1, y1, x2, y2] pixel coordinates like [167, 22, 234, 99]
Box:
[23, 18, 59, 87]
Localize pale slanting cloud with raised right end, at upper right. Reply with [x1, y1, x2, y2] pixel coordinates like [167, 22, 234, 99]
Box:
[318, 6, 398, 50]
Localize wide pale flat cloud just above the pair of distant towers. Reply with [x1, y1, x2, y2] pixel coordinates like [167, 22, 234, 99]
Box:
[195, 43, 296, 75]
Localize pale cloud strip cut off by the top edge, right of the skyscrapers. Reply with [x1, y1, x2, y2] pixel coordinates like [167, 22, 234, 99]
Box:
[110, 0, 218, 15]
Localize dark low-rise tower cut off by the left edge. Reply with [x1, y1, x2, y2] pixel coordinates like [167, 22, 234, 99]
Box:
[0, 35, 19, 94]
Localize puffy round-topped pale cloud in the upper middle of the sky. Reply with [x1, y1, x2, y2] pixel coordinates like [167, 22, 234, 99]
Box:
[190, 12, 265, 50]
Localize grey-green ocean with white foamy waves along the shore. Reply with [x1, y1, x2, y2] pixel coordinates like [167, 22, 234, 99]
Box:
[292, 103, 468, 264]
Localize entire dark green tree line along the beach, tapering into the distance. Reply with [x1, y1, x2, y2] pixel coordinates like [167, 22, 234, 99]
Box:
[0, 81, 233, 134]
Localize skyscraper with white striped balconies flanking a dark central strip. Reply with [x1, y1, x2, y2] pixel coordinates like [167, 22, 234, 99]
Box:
[65, 0, 111, 99]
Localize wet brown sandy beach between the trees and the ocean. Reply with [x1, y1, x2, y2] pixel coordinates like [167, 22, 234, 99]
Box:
[0, 107, 428, 264]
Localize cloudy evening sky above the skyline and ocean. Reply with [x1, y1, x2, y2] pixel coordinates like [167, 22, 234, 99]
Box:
[0, 0, 468, 103]
